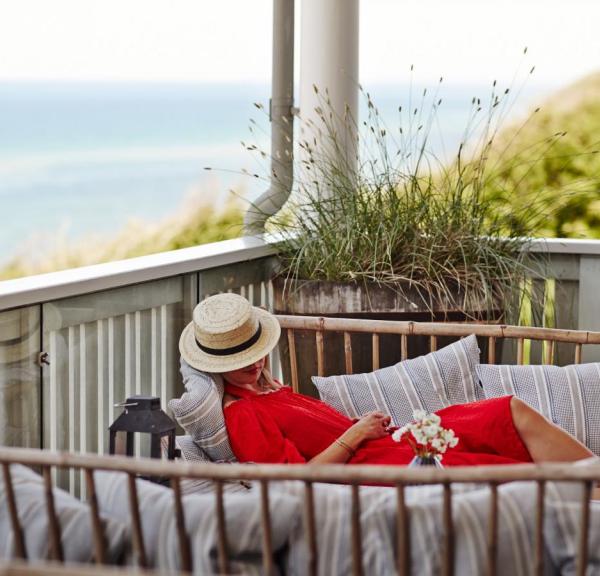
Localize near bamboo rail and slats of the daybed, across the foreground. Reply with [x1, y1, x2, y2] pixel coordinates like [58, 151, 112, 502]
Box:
[0, 448, 600, 575]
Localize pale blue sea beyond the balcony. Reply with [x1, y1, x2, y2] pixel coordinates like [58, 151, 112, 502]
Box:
[0, 82, 547, 265]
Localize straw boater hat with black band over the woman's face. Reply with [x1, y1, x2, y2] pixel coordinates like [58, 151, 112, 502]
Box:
[179, 294, 281, 373]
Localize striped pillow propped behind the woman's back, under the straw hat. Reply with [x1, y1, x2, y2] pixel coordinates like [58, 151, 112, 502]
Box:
[169, 358, 236, 462]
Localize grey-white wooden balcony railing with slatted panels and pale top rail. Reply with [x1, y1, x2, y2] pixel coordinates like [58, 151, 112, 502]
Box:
[0, 238, 600, 490]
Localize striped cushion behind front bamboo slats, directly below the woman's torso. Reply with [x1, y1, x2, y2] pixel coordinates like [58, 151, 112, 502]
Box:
[95, 472, 302, 575]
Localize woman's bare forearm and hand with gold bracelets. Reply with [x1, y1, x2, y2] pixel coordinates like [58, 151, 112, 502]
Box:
[309, 412, 391, 464]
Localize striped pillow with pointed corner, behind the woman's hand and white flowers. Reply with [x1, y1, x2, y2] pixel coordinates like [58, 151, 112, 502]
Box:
[312, 335, 483, 426]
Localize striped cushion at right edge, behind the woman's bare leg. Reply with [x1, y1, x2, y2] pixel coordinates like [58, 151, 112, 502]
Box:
[477, 363, 600, 455]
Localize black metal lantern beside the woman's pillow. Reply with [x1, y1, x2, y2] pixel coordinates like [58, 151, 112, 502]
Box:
[108, 396, 175, 460]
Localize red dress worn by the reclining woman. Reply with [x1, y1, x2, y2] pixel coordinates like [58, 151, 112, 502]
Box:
[224, 384, 532, 466]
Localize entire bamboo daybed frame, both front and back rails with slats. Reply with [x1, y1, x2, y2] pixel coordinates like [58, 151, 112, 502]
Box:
[0, 316, 600, 576]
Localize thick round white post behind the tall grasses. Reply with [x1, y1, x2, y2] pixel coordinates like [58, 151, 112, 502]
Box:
[300, 0, 359, 198]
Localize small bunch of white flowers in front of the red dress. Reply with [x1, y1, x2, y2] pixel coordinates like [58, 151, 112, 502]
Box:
[392, 410, 458, 468]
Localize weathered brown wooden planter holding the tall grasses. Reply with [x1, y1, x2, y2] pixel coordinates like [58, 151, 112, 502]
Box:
[273, 278, 501, 396]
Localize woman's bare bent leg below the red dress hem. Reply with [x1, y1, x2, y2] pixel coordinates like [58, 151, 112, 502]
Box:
[510, 396, 594, 462]
